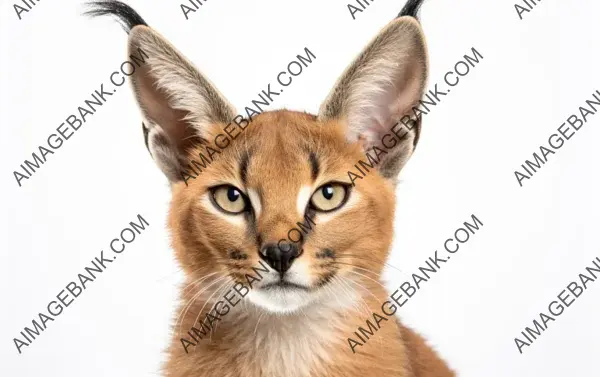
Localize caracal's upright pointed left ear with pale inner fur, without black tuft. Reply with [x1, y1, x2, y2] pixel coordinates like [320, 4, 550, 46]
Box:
[128, 25, 236, 183]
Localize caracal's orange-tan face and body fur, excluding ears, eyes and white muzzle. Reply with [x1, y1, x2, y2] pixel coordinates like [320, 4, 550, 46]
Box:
[165, 111, 454, 377]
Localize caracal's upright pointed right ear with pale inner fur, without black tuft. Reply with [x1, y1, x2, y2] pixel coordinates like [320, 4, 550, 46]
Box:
[319, 16, 428, 179]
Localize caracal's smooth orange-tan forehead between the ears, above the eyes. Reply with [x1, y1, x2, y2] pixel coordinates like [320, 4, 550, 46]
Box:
[199, 111, 360, 189]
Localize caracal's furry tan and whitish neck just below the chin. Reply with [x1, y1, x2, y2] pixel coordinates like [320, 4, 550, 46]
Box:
[166, 279, 391, 377]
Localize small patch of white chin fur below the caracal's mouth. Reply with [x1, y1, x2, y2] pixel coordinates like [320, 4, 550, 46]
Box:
[248, 288, 314, 314]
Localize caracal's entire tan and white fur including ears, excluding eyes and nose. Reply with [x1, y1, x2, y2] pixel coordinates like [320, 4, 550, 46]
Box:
[111, 8, 454, 377]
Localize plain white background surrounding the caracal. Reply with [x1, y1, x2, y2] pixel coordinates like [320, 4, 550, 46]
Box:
[0, 0, 600, 377]
